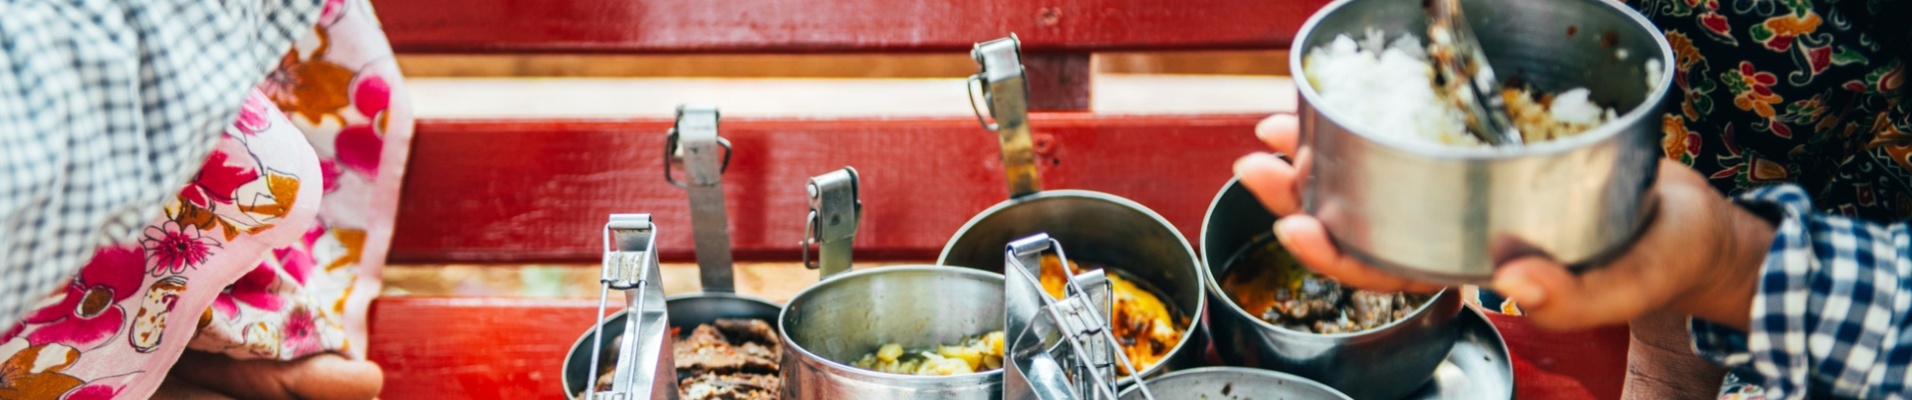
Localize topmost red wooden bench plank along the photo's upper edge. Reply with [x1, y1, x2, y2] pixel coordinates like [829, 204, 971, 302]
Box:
[373, 0, 1327, 54]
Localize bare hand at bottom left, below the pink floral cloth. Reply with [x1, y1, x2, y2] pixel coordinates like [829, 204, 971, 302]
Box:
[167, 350, 384, 400]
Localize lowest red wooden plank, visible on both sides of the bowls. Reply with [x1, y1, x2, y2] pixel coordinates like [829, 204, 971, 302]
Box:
[369, 297, 1627, 400]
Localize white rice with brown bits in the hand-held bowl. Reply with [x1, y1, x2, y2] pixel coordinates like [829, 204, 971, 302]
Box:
[1302, 31, 1614, 145]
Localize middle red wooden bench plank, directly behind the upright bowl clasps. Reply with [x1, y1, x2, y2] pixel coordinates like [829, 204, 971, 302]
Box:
[392, 113, 1266, 262]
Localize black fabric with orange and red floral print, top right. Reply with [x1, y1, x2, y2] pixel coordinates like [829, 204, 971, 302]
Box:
[1637, 0, 1912, 222]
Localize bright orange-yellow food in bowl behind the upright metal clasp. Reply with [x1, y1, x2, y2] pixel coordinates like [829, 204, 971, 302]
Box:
[1040, 255, 1187, 375]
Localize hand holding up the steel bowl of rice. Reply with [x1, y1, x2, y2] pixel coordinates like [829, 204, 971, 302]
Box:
[1235, 115, 1772, 329]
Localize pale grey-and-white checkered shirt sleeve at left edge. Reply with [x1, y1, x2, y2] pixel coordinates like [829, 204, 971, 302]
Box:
[0, 0, 319, 327]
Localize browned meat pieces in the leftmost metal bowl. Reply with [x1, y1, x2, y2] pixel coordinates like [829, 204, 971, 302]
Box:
[577, 320, 784, 400]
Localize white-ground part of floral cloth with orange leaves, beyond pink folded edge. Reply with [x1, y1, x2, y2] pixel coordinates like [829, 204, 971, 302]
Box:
[193, 0, 411, 360]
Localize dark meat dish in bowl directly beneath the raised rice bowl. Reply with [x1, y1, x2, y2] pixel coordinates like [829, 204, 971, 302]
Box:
[1222, 235, 1432, 333]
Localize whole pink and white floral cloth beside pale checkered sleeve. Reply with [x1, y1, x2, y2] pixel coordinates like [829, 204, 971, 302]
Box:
[0, 0, 411, 400]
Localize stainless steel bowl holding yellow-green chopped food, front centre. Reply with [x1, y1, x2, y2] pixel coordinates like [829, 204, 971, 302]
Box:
[780, 266, 1002, 400]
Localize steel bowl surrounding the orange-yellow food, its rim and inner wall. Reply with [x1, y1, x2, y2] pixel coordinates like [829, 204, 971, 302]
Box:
[937, 189, 1208, 383]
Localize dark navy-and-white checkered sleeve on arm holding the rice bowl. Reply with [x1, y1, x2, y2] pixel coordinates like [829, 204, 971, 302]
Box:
[1688, 186, 1912, 398]
